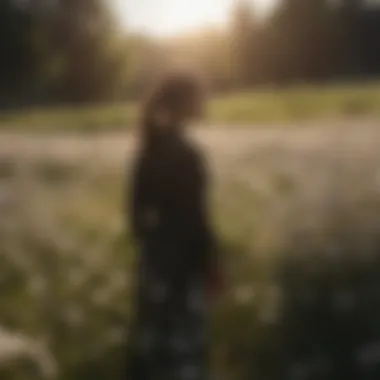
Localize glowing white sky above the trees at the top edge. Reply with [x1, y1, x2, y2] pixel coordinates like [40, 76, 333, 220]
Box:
[113, 0, 278, 36]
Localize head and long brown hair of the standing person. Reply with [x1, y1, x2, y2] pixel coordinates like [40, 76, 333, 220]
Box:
[140, 73, 203, 147]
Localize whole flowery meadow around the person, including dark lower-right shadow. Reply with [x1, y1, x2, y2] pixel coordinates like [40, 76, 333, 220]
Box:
[0, 116, 380, 380]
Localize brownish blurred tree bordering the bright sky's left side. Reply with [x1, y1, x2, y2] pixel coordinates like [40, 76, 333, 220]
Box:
[55, 0, 125, 102]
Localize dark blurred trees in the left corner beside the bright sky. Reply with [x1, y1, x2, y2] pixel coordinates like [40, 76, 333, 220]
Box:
[0, 0, 128, 106]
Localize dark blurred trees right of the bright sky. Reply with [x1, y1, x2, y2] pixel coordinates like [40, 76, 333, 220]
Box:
[230, 0, 380, 85]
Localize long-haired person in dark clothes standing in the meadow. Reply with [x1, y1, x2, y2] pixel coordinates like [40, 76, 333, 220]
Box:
[128, 73, 221, 380]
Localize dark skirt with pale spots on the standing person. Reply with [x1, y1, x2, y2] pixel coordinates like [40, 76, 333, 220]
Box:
[127, 249, 209, 380]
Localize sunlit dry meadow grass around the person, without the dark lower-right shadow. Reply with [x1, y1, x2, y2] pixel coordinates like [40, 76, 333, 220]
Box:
[0, 122, 380, 380]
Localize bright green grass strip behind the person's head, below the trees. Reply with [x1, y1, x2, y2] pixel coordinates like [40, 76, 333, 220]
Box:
[0, 83, 380, 132]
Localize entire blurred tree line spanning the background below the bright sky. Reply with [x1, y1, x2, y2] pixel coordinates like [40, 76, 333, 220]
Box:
[0, 0, 380, 107]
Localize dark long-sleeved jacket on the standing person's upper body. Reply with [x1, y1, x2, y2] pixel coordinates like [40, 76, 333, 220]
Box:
[131, 133, 215, 282]
